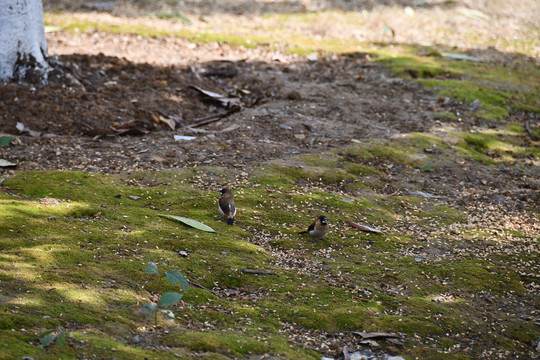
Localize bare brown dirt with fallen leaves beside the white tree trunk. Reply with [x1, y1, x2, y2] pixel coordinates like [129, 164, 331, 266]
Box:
[0, 29, 538, 205]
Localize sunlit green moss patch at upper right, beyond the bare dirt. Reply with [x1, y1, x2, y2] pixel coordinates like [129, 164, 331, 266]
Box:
[376, 45, 540, 120]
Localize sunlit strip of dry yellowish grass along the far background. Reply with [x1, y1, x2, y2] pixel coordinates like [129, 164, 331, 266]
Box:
[46, 0, 540, 58]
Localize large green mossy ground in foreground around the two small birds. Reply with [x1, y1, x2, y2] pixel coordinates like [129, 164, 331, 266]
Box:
[0, 128, 538, 359]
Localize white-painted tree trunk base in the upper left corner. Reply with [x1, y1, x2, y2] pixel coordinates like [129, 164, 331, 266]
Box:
[0, 0, 48, 81]
